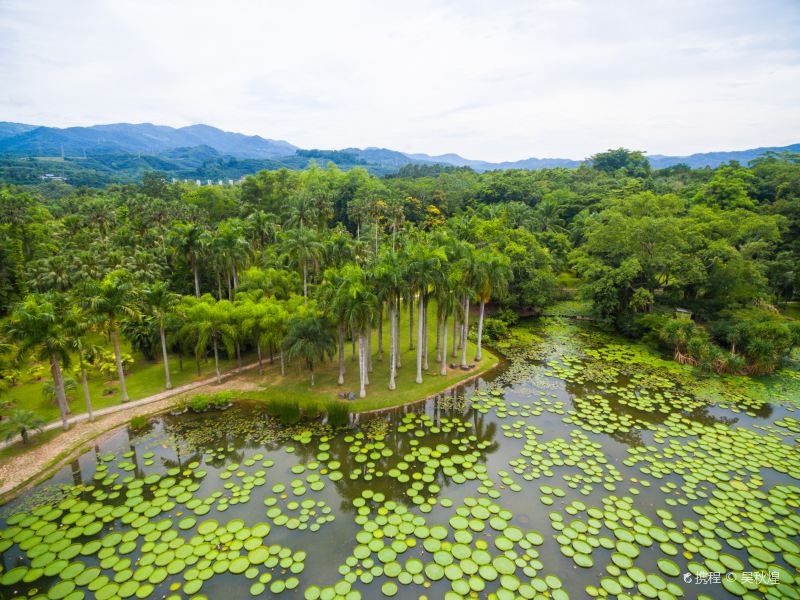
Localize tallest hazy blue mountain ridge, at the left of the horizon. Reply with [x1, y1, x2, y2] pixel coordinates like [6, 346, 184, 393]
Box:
[0, 123, 297, 158]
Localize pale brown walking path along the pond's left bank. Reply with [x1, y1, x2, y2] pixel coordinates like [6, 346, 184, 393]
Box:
[0, 363, 258, 498]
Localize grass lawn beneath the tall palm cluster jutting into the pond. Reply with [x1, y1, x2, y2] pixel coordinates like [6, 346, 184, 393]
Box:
[228, 303, 498, 412]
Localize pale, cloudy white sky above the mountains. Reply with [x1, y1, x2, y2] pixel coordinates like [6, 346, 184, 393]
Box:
[0, 0, 800, 161]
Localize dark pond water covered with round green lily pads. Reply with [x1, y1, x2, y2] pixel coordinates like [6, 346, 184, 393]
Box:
[0, 319, 800, 600]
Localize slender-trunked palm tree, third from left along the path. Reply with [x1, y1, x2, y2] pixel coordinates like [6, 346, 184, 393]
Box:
[84, 270, 140, 402]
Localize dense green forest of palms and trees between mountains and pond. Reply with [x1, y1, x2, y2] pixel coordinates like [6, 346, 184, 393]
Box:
[0, 149, 800, 432]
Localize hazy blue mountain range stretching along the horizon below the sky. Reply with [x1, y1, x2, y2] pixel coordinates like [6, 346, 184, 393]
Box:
[0, 117, 800, 184]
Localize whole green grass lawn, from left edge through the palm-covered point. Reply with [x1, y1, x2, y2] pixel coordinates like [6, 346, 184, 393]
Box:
[6, 302, 498, 422]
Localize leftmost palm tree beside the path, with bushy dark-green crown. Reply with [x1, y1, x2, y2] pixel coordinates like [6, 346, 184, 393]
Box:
[3, 292, 70, 430]
